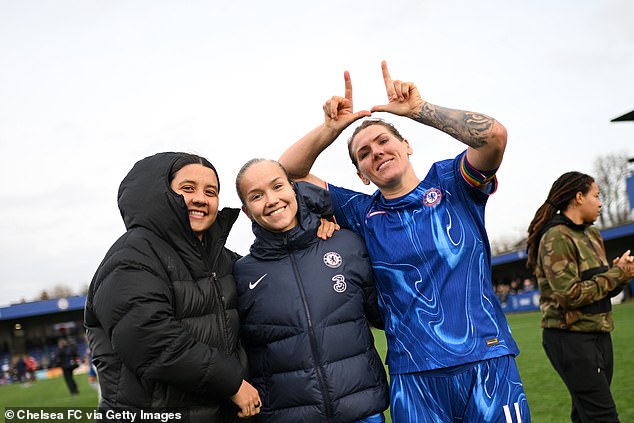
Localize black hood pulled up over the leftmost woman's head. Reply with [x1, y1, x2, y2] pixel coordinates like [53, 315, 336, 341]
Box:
[117, 152, 239, 274]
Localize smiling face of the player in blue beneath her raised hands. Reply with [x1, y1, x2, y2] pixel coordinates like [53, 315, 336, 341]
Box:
[350, 125, 418, 195]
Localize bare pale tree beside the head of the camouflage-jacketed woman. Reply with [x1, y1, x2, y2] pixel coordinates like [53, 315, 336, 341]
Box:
[593, 152, 632, 228]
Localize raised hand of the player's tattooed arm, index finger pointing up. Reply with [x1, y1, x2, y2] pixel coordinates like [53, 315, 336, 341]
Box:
[371, 60, 425, 119]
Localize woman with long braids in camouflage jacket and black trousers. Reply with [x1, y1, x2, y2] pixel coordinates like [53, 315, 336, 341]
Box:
[526, 172, 634, 423]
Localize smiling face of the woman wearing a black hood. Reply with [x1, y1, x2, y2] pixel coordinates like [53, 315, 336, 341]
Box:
[170, 164, 218, 240]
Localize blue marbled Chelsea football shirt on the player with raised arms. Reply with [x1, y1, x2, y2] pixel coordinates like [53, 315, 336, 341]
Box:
[328, 152, 519, 374]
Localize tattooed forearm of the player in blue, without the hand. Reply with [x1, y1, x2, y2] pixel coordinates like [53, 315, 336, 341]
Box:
[416, 103, 495, 149]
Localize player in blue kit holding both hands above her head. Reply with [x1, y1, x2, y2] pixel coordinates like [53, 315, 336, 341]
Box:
[280, 62, 530, 423]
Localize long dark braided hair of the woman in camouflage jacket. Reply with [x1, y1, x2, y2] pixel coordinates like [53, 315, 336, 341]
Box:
[526, 172, 594, 270]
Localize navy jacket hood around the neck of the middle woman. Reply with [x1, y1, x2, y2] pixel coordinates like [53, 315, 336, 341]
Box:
[249, 182, 334, 260]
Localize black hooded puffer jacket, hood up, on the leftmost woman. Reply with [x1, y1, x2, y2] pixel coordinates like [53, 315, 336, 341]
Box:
[85, 153, 246, 423]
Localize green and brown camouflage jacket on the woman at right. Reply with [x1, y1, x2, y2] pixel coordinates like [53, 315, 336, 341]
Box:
[535, 214, 628, 332]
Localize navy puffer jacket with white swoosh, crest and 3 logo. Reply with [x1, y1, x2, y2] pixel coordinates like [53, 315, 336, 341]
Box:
[234, 183, 389, 423]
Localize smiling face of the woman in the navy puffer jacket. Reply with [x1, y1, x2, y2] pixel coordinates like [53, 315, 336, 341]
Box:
[238, 160, 297, 232]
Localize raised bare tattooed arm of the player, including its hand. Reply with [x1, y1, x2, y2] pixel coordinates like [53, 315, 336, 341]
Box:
[372, 61, 506, 171]
